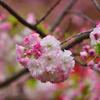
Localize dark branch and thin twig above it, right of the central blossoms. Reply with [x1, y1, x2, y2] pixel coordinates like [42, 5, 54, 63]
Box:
[61, 29, 93, 50]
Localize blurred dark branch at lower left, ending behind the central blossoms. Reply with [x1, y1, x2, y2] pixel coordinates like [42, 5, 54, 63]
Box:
[0, 69, 29, 88]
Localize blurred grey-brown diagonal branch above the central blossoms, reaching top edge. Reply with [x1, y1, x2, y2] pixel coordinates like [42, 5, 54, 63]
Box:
[50, 0, 77, 32]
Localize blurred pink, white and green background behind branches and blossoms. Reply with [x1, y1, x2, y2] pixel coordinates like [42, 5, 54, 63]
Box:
[0, 0, 100, 100]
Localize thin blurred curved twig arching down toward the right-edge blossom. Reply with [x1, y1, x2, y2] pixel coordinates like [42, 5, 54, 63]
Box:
[68, 10, 96, 27]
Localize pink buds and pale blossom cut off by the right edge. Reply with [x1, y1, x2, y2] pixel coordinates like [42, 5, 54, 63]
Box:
[80, 24, 100, 72]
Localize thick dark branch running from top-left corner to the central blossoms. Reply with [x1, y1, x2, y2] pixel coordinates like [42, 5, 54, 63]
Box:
[0, 0, 46, 37]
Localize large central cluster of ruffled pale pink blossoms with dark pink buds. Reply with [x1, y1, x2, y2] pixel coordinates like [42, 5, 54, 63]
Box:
[16, 32, 75, 83]
